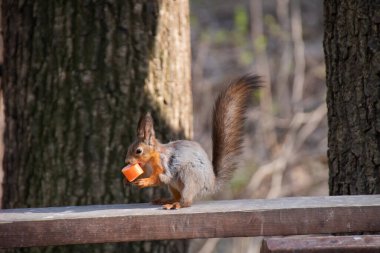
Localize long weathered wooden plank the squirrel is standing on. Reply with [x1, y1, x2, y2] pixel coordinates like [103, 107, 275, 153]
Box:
[0, 195, 380, 248]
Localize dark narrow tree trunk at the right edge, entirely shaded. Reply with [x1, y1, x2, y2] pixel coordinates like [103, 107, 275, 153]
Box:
[324, 0, 380, 195]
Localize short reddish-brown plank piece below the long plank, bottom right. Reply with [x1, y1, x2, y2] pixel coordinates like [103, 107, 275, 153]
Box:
[260, 235, 380, 253]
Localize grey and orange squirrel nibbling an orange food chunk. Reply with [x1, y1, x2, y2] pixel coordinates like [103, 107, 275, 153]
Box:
[125, 74, 262, 209]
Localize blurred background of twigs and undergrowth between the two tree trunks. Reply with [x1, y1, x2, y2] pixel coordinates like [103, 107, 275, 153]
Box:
[190, 0, 328, 253]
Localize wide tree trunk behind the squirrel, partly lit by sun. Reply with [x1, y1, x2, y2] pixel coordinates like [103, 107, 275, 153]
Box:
[1, 0, 192, 252]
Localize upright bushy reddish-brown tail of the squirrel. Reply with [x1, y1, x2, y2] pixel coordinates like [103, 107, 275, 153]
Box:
[212, 75, 262, 189]
